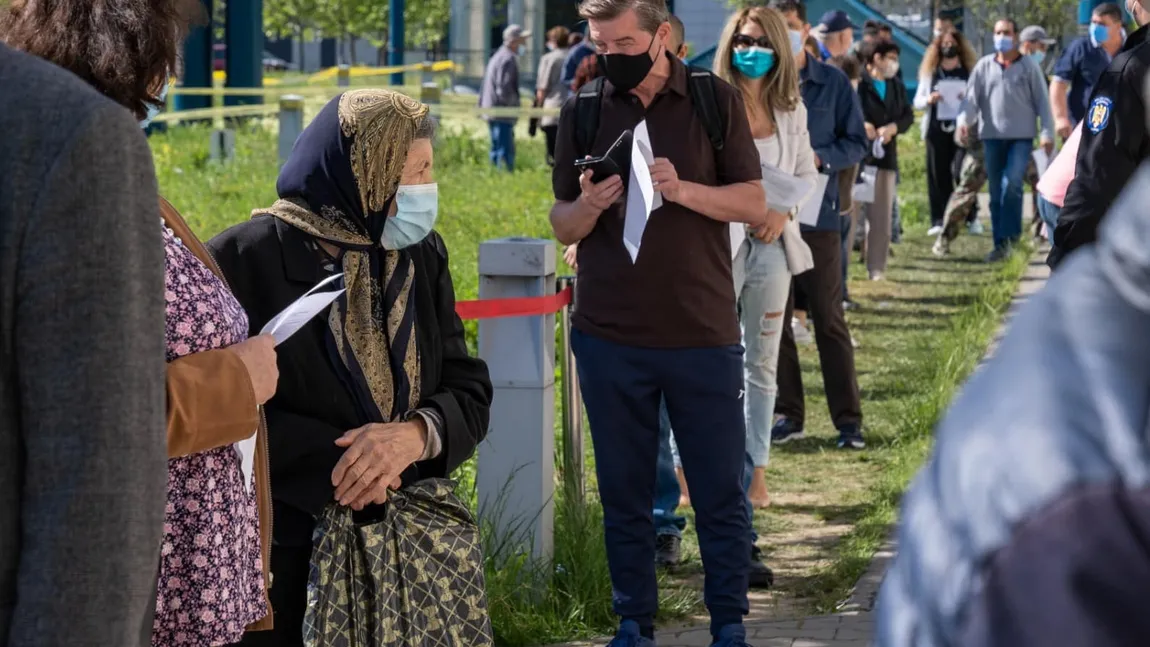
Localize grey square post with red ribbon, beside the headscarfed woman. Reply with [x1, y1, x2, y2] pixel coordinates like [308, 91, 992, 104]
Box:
[476, 238, 555, 560]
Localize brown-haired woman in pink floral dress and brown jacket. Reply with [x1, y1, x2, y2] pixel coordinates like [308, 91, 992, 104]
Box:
[0, 0, 277, 647]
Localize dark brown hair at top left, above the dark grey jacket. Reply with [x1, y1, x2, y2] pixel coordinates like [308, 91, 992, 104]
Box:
[0, 0, 206, 118]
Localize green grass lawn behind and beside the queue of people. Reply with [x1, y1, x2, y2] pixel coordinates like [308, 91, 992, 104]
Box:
[152, 121, 1022, 647]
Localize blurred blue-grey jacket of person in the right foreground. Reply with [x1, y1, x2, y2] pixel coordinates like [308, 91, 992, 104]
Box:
[877, 165, 1150, 647]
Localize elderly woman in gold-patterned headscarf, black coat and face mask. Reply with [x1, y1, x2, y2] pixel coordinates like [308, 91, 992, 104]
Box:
[209, 90, 491, 647]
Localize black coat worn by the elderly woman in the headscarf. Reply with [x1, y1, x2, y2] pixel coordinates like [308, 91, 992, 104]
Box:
[208, 216, 491, 546]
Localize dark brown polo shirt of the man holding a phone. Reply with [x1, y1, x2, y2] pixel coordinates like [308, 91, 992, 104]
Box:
[552, 56, 762, 348]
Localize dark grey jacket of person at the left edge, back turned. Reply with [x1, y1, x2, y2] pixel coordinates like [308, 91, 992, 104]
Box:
[0, 45, 167, 647]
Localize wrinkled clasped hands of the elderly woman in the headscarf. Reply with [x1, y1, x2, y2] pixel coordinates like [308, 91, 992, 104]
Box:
[331, 416, 428, 510]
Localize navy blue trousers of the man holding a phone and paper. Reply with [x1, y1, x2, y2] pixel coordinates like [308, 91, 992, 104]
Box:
[572, 331, 751, 632]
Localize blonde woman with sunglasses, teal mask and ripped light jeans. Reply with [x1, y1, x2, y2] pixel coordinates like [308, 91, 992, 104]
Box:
[714, 7, 818, 508]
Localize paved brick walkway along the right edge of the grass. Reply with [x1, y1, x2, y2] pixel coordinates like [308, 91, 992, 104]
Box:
[547, 247, 1050, 647]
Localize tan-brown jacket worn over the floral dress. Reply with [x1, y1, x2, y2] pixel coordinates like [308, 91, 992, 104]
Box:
[160, 198, 273, 631]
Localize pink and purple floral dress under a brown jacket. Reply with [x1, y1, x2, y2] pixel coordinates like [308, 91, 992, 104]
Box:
[152, 220, 268, 647]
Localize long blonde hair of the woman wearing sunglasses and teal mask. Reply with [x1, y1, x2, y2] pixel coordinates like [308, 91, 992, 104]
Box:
[714, 7, 803, 123]
